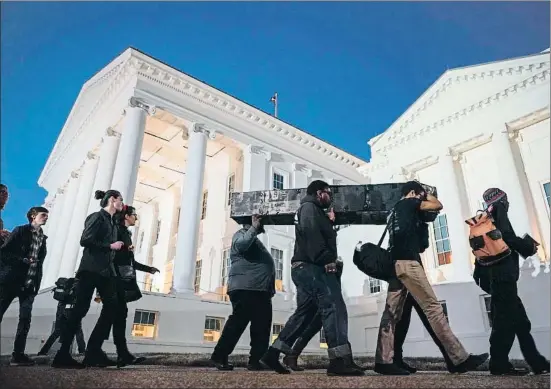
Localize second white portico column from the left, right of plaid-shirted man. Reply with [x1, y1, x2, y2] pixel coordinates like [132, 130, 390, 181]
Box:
[48, 172, 80, 282]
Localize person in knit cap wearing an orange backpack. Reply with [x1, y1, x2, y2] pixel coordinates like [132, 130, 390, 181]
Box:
[466, 188, 549, 376]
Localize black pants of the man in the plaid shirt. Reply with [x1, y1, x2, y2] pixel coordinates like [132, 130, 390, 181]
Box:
[0, 284, 35, 354]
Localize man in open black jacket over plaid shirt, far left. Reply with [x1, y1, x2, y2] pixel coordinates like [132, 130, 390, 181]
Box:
[0, 207, 48, 366]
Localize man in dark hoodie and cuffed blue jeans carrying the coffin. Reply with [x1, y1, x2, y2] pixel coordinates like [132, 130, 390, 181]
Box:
[262, 180, 364, 375]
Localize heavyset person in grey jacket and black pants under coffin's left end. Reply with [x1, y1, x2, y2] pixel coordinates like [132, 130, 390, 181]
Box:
[211, 215, 275, 370]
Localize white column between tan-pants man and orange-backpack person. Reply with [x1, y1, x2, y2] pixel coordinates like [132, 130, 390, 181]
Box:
[437, 155, 472, 281]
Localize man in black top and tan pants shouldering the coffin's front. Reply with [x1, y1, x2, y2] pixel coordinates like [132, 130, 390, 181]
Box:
[374, 181, 488, 375]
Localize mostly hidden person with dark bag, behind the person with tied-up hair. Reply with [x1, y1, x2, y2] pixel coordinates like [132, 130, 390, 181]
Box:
[38, 278, 86, 355]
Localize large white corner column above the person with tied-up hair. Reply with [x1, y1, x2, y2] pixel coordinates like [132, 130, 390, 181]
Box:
[110, 99, 149, 204]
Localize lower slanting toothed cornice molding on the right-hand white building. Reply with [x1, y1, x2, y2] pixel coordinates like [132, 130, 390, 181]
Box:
[375, 69, 550, 153]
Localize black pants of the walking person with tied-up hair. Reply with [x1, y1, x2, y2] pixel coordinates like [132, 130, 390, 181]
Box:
[59, 272, 126, 355]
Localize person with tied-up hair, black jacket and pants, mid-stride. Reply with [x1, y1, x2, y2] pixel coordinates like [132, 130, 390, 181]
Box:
[52, 189, 127, 369]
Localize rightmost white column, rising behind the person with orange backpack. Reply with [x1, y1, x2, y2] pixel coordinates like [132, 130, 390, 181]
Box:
[492, 130, 536, 237]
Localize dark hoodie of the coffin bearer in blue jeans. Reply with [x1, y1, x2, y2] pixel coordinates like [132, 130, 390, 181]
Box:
[291, 195, 337, 266]
